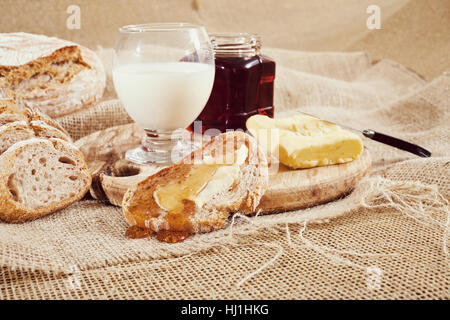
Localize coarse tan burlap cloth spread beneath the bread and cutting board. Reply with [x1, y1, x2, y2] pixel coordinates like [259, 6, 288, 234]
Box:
[0, 49, 450, 299]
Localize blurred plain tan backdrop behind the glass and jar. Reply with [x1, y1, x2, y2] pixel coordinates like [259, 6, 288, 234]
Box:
[0, 0, 450, 80]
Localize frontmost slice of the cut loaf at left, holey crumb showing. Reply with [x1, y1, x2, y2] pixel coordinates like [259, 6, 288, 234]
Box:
[0, 138, 91, 222]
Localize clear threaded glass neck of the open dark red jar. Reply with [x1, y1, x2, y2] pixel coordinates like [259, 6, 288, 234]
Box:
[209, 32, 261, 56]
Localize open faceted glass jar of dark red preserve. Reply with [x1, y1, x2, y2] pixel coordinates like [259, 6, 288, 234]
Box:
[189, 33, 275, 135]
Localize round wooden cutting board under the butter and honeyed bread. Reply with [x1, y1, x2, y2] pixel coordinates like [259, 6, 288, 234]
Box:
[76, 124, 371, 213]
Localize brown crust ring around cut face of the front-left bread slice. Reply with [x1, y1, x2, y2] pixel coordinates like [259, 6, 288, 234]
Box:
[0, 138, 91, 222]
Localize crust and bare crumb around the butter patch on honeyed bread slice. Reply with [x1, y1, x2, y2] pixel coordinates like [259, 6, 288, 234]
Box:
[122, 131, 268, 233]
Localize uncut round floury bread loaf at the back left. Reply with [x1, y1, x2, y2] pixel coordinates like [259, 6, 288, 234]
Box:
[0, 33, 105, 117]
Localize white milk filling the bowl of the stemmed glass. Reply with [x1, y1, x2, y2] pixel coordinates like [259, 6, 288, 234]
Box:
[112, 62, 214, 130]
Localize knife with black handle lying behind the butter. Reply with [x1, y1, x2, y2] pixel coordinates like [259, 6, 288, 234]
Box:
[296, 111, 431, 158]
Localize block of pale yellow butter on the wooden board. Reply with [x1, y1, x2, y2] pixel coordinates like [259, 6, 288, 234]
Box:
[247, 115, 363, 169]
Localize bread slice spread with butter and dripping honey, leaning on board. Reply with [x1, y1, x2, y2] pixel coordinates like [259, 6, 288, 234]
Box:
[122, 131, 268, 233]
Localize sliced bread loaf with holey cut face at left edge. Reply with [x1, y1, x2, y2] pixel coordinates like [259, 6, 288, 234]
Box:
[0, 99, 91, 222]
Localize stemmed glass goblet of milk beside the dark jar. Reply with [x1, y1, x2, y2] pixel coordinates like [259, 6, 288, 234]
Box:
[112, 23, 214, 165]
